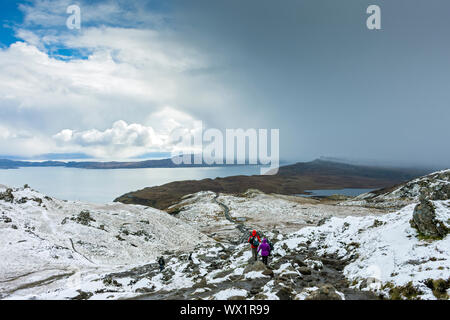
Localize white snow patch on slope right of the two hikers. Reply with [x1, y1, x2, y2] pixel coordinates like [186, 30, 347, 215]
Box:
[276, 200, 450, 299]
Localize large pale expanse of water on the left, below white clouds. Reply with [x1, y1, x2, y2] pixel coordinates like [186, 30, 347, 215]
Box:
[0, 165, 260, 203]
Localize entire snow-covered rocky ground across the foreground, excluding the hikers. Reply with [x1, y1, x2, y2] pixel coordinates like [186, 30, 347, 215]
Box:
[0, 170, 450, 300]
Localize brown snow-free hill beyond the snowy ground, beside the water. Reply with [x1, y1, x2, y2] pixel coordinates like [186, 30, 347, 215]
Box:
[115, 159, 431, 209]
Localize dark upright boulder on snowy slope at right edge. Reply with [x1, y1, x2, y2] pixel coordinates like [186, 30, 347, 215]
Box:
[411, 197, 448, 238]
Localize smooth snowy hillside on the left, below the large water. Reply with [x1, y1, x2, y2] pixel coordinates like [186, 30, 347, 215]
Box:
[0, 186, 209, 297]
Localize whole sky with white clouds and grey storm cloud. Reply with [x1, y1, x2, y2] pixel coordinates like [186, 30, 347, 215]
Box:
[0, 0, 450, 167]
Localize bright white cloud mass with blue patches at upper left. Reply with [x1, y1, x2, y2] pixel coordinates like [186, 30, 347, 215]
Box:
[0, 0, 236, 157]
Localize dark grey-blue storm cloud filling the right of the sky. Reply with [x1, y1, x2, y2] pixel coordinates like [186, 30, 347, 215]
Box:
[171, 0, 450, 166]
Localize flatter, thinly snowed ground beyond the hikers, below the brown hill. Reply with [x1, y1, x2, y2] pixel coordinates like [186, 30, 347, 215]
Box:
[172, 190, 385, 235]
